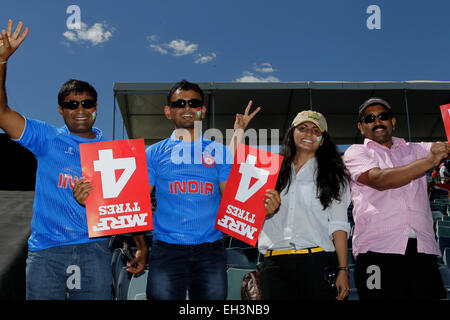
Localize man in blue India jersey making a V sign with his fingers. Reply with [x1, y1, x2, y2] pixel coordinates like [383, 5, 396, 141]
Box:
[142, 80, 272, 300]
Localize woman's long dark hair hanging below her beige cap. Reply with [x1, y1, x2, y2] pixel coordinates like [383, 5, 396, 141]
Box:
[275, 127, 350, 210]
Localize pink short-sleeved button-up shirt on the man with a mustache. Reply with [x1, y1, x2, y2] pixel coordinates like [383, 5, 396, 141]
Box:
[344, 137, 441, 257]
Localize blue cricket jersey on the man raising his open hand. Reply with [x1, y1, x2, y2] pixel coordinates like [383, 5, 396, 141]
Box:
[15, 118, 107, 251]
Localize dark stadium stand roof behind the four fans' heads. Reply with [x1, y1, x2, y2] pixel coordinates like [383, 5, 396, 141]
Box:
[113, 81, 450, 145]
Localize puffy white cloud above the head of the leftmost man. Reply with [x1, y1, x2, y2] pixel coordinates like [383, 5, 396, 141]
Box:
[63, 22, 114, 46]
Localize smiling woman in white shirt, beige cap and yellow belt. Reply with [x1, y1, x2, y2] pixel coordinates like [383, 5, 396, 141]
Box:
[258, 110, 350, 300]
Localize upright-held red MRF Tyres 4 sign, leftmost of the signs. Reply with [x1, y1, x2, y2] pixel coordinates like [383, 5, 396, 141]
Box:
[80, 139, 153, 238]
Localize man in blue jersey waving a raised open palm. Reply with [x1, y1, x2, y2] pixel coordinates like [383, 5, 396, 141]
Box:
[0, 20, 147, 300]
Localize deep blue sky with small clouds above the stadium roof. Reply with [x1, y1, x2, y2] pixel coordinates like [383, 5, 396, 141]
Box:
[0, 0, 450, 138]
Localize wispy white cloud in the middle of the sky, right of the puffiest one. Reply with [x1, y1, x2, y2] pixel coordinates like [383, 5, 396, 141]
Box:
[147, 35, 217, 64]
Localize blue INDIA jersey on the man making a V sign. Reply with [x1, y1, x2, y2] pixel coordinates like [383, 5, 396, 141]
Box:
[146, 133, 233, 245]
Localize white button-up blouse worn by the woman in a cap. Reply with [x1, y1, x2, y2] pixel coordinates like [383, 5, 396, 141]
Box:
[258, 158, 350, 254]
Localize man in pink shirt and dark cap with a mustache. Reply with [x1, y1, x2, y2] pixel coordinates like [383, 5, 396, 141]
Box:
[344, 98, 450, 299]
